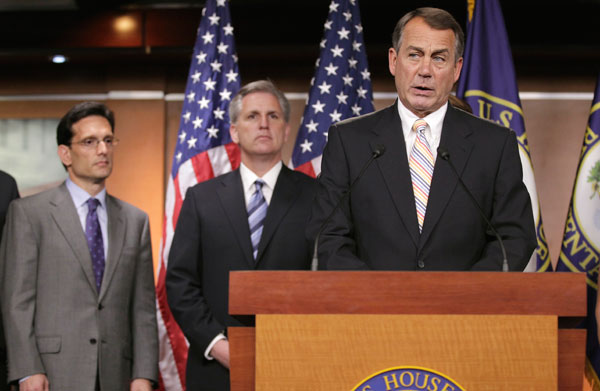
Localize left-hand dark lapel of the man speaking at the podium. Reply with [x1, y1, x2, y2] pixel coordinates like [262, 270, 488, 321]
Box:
[371, 104, 419, 246]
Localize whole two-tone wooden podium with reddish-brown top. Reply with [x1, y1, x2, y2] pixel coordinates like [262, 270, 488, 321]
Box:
[228, 271, 587, 391]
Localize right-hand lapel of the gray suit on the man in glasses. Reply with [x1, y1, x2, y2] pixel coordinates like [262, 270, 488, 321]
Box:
[100, 194, 127, 300]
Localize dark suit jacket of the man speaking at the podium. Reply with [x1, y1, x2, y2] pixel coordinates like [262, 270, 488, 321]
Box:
[308, 104, 536, 270]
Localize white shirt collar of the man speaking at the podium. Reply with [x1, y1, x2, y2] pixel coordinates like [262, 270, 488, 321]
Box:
[398, 99, 448, 162]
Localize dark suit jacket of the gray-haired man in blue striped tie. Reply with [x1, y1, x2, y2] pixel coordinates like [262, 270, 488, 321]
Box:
[166, 166, 316, 391]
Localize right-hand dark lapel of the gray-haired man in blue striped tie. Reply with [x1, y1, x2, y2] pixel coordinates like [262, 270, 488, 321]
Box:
[256, 165, 303, 265]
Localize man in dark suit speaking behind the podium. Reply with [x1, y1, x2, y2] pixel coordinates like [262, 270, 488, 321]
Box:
[308, 8, 536, 271]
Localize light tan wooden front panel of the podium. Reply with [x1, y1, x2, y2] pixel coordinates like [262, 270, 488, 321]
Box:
[255, 315, 558, 391]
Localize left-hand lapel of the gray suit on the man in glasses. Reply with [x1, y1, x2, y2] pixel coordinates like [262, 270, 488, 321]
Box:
[50, 183, 98, 294]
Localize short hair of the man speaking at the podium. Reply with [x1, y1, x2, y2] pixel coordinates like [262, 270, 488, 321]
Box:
[392, 7, 465, 62]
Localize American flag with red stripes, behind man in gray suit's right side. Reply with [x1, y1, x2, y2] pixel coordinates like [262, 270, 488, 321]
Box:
[156, 0, 240, 391]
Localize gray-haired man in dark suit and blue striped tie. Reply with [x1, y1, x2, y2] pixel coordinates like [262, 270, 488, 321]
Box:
[166, 81, 316, 391]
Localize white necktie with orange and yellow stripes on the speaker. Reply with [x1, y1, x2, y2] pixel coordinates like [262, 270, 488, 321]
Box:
[408, 119, 433, 232]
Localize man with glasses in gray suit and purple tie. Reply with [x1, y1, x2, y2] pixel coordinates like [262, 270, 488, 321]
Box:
[0, 102, 158, 391]
